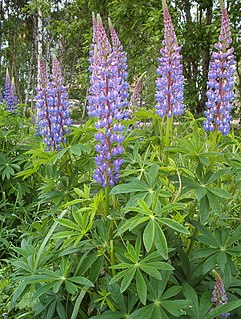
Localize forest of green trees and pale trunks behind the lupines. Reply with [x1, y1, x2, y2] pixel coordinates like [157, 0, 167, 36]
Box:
[0, 0, 241, 114]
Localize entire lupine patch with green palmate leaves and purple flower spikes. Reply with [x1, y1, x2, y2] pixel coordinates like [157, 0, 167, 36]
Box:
[0, 0, 241, 319]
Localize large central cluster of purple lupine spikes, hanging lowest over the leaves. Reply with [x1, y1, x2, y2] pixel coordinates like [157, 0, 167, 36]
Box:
[87, 15, 128, 190]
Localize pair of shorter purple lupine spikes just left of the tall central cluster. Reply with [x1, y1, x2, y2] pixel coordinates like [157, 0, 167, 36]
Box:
[35, 55, 71, 151]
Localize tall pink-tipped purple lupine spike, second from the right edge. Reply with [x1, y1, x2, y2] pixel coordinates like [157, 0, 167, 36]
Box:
[155, 0, 184, 117]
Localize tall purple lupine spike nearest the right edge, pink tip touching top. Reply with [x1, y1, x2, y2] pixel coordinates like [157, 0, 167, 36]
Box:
[204, 1, 235, 135]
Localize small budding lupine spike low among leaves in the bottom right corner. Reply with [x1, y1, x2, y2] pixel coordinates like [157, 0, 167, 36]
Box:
[211, 270, 230, 319]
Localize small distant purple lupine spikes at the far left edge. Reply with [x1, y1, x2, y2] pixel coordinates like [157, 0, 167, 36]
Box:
[4, 69, 18, 114]
